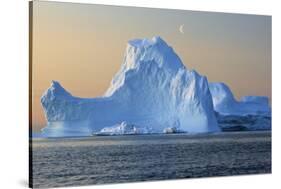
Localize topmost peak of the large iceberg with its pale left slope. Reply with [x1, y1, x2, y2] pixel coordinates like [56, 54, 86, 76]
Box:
[105, 36, 186, 96]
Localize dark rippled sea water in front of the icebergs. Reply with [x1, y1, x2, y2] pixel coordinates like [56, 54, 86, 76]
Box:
[32, 131, 271, 188]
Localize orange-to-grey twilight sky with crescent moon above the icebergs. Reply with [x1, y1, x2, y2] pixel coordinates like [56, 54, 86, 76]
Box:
[32, 1, 272, 132]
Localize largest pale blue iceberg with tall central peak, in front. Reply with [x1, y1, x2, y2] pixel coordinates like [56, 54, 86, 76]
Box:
[41, 37, 220, 136]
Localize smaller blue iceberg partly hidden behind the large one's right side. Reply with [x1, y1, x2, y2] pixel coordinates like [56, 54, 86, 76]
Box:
[209, 83, 271, 131]
